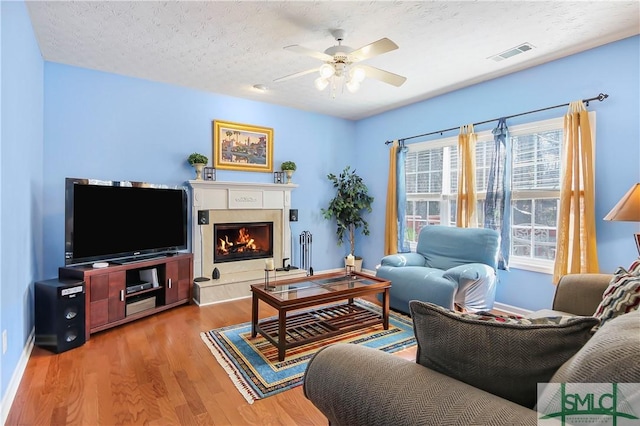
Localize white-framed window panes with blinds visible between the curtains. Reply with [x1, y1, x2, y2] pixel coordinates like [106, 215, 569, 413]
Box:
[405, 112, 595, 272]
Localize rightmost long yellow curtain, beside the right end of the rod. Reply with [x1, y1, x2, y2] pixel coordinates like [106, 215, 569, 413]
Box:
[553, 101, 599, 284]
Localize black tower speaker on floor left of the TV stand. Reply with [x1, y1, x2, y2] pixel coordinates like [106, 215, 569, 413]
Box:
[35, 279, 86, 353]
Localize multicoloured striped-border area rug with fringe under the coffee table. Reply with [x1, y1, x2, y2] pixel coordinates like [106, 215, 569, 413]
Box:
[200, 300, 416, 404]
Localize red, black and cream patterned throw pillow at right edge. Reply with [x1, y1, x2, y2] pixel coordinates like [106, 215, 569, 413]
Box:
[593, 260, 640, 327]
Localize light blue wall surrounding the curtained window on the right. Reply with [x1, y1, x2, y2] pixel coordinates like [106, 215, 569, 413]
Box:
[355, 36, 640, 310]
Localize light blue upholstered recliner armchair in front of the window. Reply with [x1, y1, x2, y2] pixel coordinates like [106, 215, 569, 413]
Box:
[376, 225, 500, 314]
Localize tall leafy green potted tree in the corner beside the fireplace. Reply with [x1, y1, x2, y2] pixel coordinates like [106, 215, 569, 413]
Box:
[322, 166, 373, 270]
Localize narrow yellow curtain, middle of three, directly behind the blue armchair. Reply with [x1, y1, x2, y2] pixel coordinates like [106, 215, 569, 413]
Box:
[456, 124, 478, 228]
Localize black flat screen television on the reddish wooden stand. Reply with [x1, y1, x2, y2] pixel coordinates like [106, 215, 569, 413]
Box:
[65, 178, 187, 265]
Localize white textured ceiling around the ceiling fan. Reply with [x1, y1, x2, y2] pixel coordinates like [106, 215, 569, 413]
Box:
[27, 1, 640, 120]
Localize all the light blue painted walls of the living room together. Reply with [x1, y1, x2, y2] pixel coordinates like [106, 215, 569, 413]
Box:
[0, 2, 640, 410]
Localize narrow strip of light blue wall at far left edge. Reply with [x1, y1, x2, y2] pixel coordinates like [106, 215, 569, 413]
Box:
[0, 1, 44, 406]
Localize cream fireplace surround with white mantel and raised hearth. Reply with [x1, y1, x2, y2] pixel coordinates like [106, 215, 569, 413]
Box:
[189, 180, 306, 305]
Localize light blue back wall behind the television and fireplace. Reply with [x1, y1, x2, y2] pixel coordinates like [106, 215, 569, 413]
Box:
[43, 62, 355, 277]
